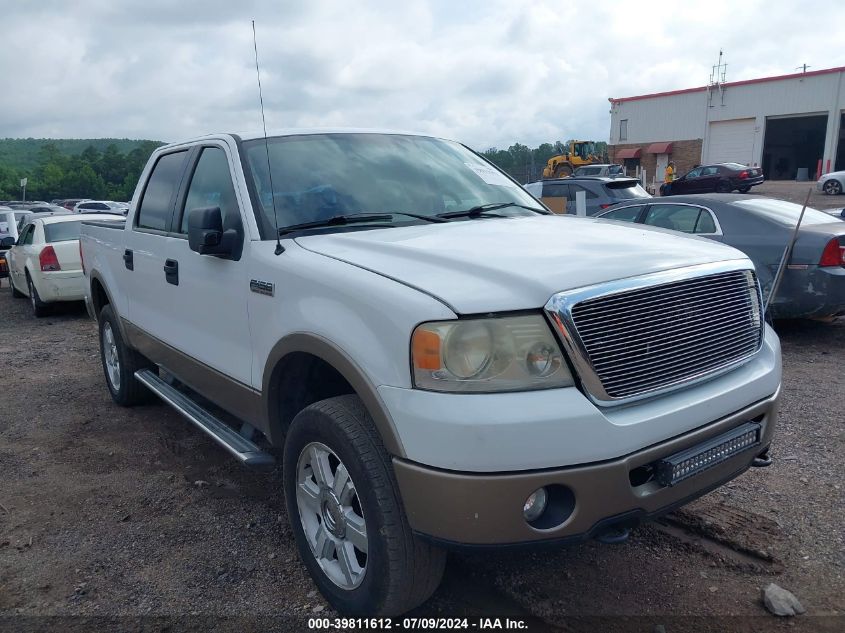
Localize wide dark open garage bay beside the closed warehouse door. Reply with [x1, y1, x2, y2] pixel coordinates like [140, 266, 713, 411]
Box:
[763, 114, 827, 180]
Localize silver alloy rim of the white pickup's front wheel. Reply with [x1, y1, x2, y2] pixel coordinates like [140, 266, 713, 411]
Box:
[296, 442, 367, 590]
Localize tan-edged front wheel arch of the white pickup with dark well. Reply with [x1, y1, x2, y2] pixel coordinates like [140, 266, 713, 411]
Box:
[261, 332, 405, 457]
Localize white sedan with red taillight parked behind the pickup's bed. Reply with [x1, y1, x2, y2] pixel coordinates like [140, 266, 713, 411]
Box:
[6, 213, 124, 317]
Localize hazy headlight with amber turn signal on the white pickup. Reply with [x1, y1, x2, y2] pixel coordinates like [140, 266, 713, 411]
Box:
[411, 314, 573, 391]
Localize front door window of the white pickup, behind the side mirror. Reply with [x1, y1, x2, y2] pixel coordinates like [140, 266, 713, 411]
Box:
[180, 147, 240, 233]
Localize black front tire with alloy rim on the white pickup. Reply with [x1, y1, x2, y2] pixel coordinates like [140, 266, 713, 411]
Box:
[283, 395, 446, 617]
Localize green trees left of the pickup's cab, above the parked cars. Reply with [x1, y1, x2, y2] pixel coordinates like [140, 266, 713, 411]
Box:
[0, 140, 162, 201]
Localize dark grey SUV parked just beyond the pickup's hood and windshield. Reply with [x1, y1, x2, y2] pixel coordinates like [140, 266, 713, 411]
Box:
[525, 176, 651, 215]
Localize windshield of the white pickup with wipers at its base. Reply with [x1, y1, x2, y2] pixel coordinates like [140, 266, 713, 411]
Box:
[243, 133, 540, 239]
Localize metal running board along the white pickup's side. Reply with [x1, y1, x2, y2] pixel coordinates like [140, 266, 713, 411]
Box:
[135, 369, 276, 470]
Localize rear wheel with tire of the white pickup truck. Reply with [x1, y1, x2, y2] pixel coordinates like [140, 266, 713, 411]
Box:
[99, 304, 155, 407]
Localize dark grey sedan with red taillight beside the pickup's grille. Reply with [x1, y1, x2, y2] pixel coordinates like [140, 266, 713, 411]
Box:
[599, 194, 845, 319]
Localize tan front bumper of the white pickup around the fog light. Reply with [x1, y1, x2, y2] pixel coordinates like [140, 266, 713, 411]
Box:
[393, 392, 780, 545]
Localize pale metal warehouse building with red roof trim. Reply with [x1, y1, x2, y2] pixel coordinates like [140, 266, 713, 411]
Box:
[608, 67, 845, 182]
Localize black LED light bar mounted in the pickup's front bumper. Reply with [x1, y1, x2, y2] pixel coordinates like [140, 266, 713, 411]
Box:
[654, 422, 761, 486]
